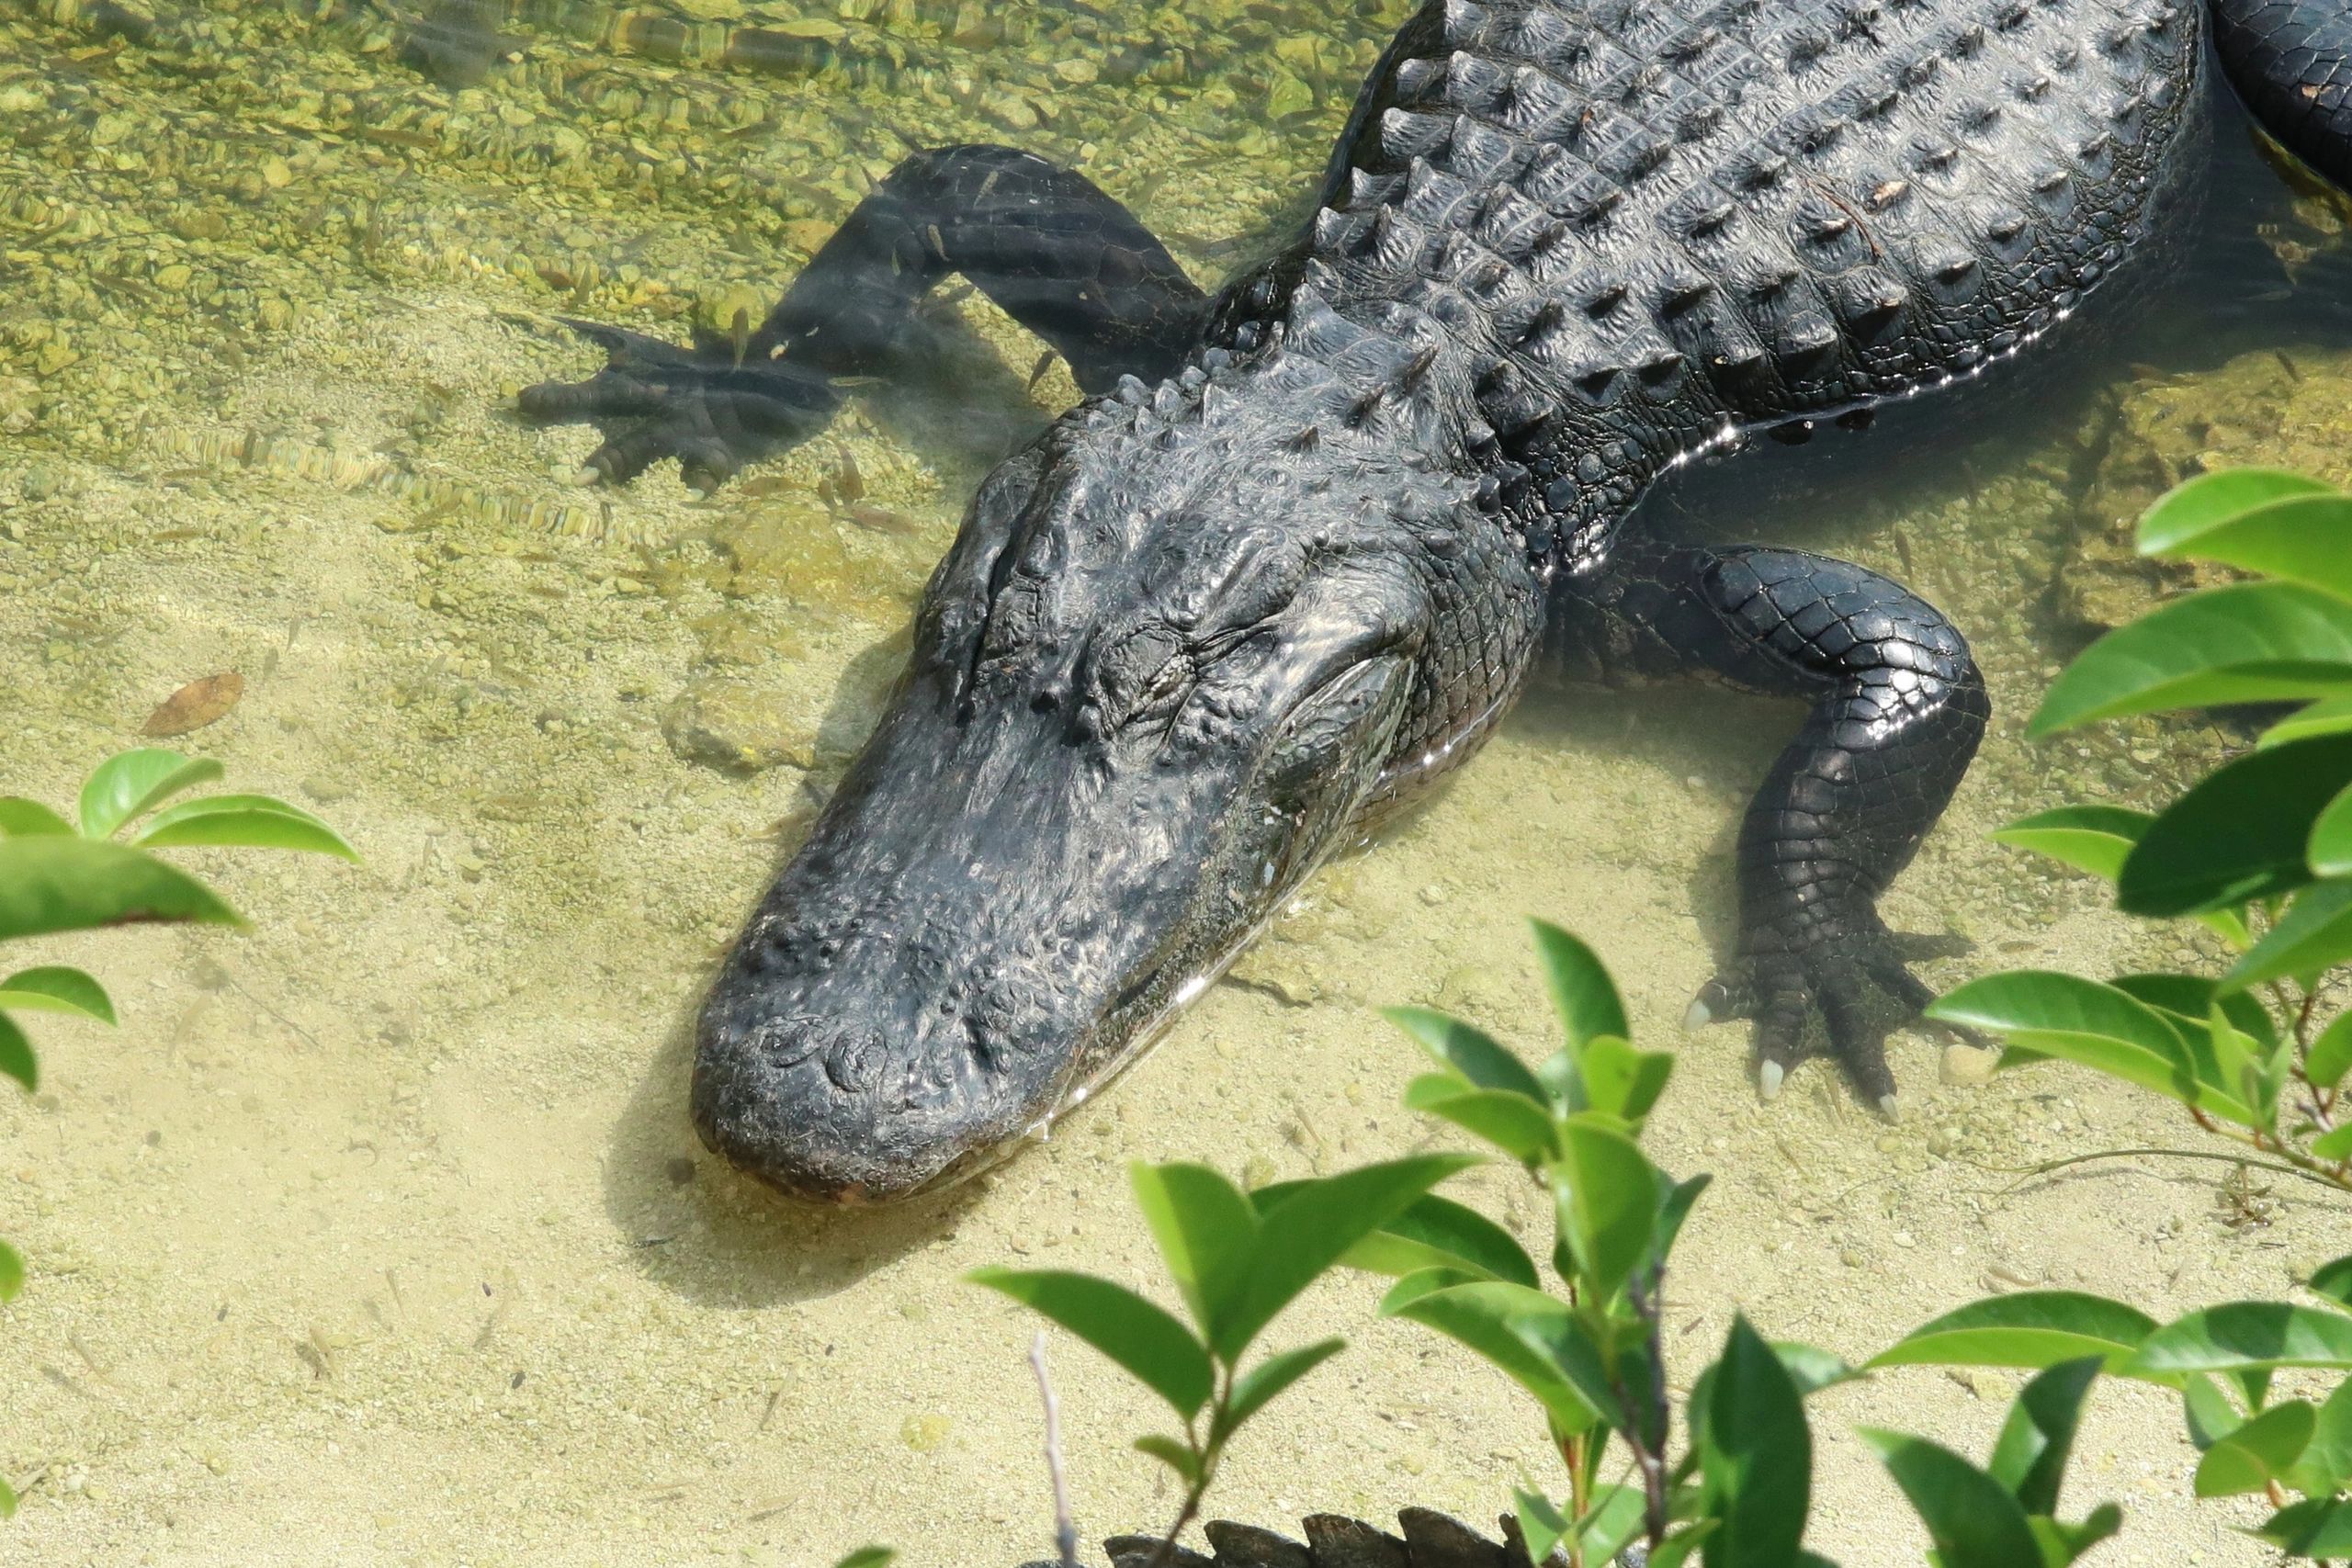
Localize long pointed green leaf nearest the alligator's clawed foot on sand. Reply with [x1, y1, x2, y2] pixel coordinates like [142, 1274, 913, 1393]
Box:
[1927, 968, 2256, 1126]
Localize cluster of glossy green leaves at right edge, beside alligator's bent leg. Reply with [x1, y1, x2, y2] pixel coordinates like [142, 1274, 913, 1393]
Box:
[1966, 470, 2352, 1222]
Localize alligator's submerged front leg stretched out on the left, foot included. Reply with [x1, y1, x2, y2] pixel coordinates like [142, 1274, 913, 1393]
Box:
[520, 146, 1204, 489]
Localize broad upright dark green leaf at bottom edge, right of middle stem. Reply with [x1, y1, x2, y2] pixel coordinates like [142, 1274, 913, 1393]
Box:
[1701, 1314, 1806, 1568]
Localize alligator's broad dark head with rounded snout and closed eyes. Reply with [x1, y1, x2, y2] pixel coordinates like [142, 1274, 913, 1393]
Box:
[692, 341, 1538, 1201]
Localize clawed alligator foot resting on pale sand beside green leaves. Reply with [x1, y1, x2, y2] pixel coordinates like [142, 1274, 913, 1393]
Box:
[1684, 915, 1985, 1122]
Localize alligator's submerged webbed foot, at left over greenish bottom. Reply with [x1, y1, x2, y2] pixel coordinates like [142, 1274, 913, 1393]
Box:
[517, 317, 840, 493]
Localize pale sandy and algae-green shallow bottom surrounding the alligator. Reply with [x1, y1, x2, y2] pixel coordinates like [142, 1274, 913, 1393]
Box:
[0, 0, 2352, 1568]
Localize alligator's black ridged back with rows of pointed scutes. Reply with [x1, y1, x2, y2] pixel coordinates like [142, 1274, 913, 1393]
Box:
[1279, 0, 2201, 569]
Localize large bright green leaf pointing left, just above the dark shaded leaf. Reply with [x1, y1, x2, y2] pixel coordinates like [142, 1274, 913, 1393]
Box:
[2025, 583, 2352, 739]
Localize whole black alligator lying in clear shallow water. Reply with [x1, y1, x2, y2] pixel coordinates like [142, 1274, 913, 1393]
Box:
[520, 0, 2347, 1201]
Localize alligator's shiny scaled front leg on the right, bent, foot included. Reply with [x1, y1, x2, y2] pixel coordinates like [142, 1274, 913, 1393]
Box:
[1557, 543, 1992, 1114]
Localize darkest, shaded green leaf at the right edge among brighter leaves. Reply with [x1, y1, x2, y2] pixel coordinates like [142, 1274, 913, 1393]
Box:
[2114, 738, 2352, 915]
